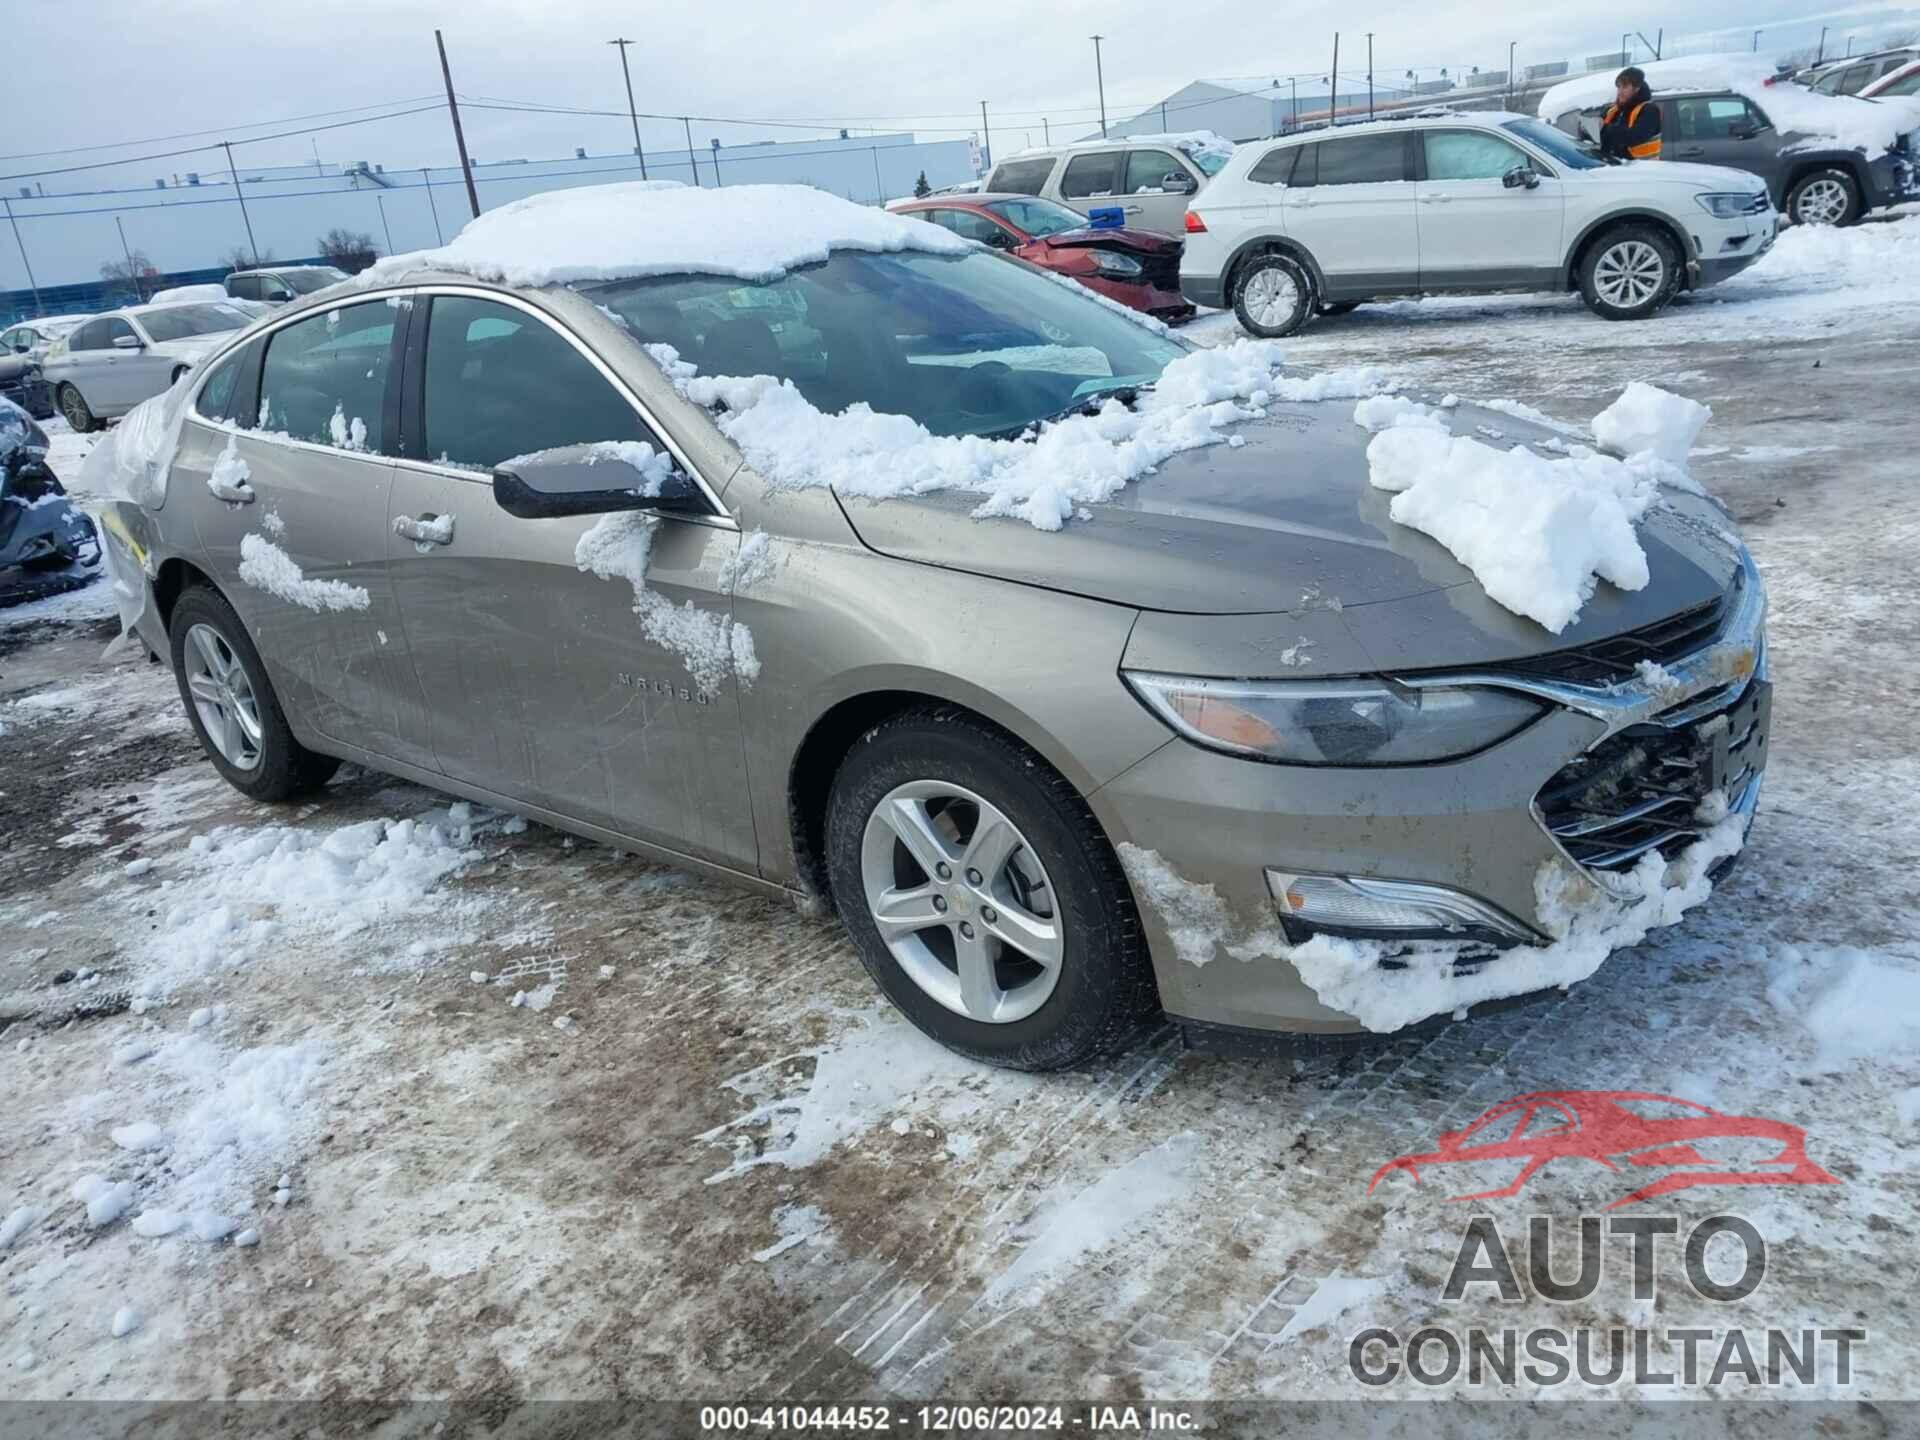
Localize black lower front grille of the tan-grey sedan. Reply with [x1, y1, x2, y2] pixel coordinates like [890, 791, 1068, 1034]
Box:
[1534, 680, 1772, 870]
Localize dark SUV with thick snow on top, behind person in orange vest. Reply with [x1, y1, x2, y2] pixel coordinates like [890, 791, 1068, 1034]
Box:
[1540, 56, 1920, 225]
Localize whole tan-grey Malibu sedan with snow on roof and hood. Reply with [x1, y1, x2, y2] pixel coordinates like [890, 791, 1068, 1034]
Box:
[84, 182, 1770, 1068]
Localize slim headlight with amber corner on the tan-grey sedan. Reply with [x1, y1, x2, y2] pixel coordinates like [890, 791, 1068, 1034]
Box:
[1123, 670, 1546, 766]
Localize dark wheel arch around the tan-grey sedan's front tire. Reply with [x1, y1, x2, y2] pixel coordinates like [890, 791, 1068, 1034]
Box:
[787, 674, 1112, 899]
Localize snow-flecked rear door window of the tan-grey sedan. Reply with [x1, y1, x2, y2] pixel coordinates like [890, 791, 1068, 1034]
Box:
[259, 300, 403, 451]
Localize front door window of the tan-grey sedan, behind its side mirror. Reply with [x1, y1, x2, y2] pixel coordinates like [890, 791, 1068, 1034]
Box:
[420, 296, 660, 470]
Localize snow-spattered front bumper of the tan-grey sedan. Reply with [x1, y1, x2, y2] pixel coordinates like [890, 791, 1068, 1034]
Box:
[1092, 559, 1766, 1035]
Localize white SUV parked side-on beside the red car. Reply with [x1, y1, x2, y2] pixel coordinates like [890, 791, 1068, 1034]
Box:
[1181, 111, 1780, 338]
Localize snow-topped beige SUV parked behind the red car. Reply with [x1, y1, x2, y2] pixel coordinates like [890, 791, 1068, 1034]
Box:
[981, 131, 1233, 236]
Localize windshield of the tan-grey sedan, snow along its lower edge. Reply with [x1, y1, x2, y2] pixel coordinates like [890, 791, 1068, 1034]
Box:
[586, 252, 1190, 436]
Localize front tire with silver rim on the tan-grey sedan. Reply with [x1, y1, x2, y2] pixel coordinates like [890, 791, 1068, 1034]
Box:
[826, 707, 1158, 1069]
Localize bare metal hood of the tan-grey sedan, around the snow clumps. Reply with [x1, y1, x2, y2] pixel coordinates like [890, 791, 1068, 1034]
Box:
[843, 399, 1740, 664]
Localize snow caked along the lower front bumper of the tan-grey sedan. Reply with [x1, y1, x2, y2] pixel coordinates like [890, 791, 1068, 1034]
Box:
[1286, 814, 1747, 1033]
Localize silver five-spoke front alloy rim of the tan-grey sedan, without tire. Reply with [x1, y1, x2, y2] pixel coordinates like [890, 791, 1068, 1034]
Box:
[860, 780, 1066, 1025]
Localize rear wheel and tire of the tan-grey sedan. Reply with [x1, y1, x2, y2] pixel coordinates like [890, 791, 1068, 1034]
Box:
[167, 586, 340, 814]
